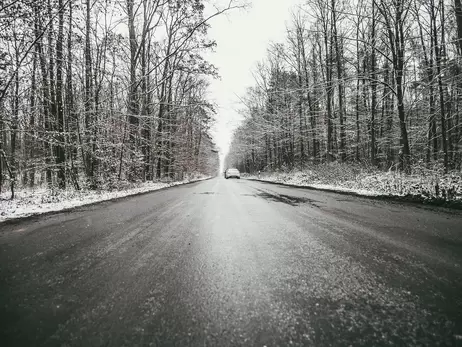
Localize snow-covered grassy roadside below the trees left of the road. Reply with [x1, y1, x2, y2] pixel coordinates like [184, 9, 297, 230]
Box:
[0, 177, 210, 223]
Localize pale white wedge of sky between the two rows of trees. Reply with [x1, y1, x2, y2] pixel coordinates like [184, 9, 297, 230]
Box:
[207, 0, 303, 164]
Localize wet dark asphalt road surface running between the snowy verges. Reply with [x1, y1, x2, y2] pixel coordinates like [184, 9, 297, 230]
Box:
[0, 178, 462, 347]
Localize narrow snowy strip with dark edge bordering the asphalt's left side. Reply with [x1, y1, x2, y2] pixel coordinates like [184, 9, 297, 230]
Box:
[0, 177, 212, 226]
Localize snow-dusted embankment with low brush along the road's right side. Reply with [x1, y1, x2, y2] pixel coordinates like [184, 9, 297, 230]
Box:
[245, 163, 462, 208]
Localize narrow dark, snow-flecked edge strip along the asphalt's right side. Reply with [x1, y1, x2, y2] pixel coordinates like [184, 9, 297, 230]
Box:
[243, 177, 462, 210]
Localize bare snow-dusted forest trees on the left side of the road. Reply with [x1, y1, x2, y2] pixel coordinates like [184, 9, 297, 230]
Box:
[0, 0, 236, 196]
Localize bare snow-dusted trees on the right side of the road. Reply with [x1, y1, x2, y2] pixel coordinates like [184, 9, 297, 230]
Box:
[226, 0, 462, 173]
